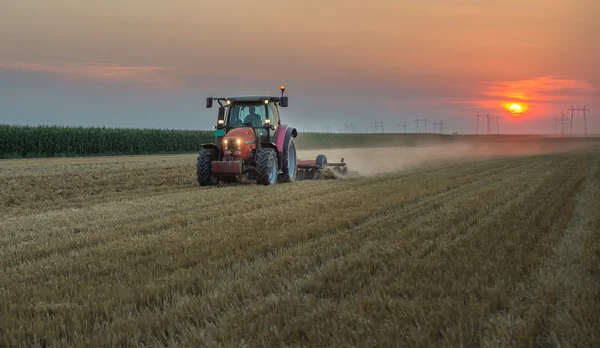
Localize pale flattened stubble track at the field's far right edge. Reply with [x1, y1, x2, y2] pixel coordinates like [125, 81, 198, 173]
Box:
[483, 155, 600, 347]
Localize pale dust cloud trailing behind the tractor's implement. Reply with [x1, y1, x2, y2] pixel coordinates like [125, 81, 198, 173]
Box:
[298, 141, 600, 176]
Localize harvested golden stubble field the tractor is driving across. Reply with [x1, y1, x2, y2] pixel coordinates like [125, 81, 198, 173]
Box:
[0, 142, 600, 347]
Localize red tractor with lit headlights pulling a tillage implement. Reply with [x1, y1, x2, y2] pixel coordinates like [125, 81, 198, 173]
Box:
[196, 86, 346, 186]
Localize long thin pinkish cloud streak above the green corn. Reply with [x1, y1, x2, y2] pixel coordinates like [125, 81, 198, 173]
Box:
[0, 61, 178, 87]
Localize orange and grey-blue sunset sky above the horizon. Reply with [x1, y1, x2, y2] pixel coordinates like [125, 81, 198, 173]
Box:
[0, 0, 600, 133]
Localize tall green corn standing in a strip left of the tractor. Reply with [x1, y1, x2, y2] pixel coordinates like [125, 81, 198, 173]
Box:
[0, 125, 214, 158]
